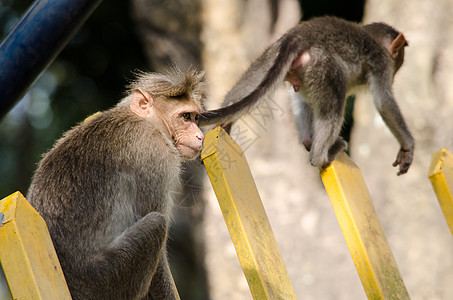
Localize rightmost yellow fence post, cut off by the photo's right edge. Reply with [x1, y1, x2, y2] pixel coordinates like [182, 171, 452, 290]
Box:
[428, 148, 453, 234]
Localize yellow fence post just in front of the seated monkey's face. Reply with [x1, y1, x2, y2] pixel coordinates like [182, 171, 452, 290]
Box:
[201, 127, 296, 300]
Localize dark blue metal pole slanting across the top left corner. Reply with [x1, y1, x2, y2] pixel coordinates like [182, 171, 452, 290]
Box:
[0, 0, 102, 119]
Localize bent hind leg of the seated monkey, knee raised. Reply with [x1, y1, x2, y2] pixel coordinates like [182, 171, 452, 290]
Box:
[78, 212, 168, 299]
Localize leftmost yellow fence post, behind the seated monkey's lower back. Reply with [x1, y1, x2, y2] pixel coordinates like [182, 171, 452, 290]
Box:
[0, 192, 71, 300]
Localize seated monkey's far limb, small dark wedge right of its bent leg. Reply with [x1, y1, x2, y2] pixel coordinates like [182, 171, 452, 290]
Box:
[146, 251, 178, 300]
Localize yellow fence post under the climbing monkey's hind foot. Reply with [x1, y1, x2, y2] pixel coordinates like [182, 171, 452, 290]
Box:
[321, 153, 409, 299]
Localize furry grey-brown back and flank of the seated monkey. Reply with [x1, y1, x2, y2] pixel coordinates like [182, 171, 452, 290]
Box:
[27, 107, 180, 272]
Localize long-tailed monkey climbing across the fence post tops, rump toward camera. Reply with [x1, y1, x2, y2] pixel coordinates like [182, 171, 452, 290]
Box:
[200, 17, 414, 175]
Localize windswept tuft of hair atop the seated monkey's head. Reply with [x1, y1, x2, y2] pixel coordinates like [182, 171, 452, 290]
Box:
[126, 67, 206, 107]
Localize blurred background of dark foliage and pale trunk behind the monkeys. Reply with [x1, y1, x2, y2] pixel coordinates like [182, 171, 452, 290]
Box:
[0, 0, 453, 300]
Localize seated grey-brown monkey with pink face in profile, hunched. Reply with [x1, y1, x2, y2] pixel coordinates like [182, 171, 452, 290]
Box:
[27, 69, 205, 299]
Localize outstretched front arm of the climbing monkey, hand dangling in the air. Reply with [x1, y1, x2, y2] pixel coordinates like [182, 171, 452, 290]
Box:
[370, 80, 415, 175]
